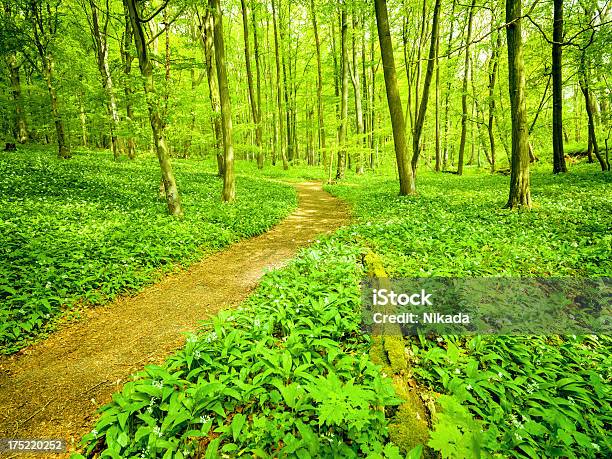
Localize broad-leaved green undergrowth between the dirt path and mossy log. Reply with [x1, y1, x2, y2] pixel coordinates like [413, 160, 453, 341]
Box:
[76, 240, 400, 458]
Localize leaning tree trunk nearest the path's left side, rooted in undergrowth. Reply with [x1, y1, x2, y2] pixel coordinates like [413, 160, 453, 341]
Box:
[124, 0, 183, 216]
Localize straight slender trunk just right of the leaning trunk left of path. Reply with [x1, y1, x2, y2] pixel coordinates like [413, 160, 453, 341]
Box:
[208, 0, 236, 202]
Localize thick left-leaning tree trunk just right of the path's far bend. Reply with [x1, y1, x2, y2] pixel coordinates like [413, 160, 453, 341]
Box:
[374, 0, 416, 195]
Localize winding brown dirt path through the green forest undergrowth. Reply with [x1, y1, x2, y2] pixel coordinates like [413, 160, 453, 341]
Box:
[0, 183, 348, 458]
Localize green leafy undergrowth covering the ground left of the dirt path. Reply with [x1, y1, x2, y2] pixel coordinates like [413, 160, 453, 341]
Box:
[0, 150, 297, 353]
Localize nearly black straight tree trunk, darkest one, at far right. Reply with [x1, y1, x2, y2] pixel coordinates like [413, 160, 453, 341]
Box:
[551, 0, 567, 174]
